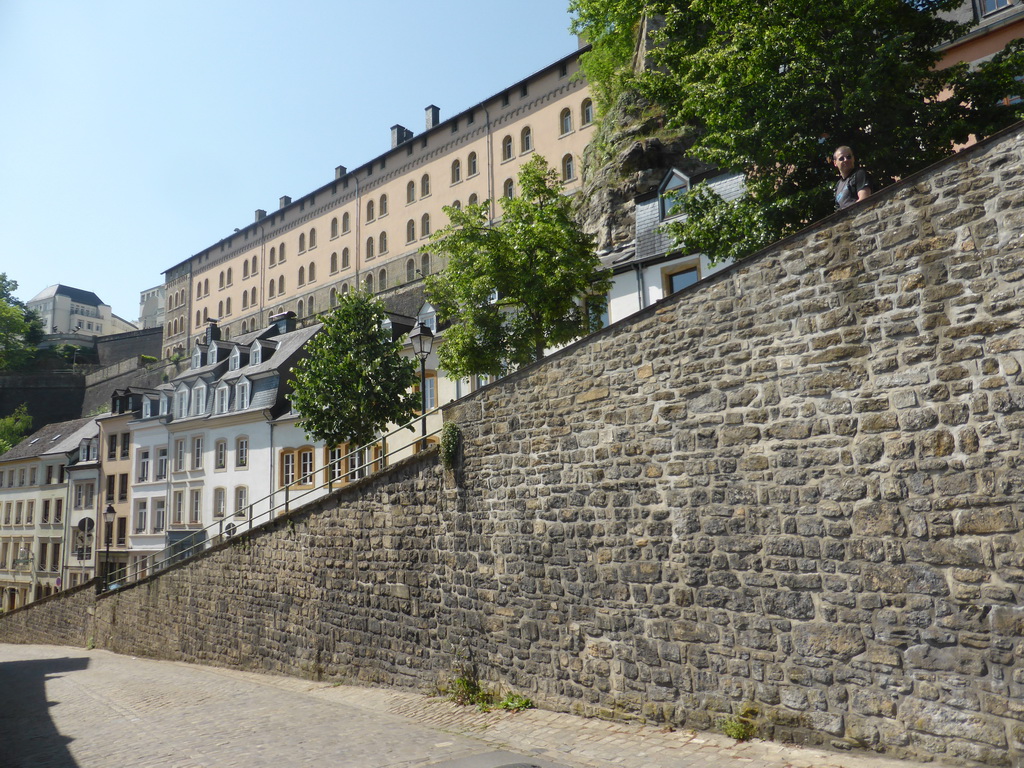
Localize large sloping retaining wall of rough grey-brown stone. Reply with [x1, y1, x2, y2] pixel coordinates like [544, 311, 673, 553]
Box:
[6, 123, 1024, 765]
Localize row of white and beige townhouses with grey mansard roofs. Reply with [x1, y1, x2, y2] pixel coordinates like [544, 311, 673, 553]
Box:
[0, 312, 438, 610]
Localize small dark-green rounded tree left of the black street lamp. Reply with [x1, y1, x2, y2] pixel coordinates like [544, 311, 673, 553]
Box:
[289, 291, 420, 445]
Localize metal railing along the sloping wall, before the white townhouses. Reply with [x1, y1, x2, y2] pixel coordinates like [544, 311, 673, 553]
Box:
[99, 408, 441, 591]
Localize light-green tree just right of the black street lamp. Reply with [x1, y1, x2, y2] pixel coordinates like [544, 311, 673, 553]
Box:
[425, 155, 610, 378]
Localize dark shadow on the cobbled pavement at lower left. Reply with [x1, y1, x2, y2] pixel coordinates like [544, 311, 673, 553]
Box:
[0, 657, 89, 768]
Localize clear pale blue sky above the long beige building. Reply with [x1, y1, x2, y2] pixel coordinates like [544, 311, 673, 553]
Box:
[0, 0, 577, 321]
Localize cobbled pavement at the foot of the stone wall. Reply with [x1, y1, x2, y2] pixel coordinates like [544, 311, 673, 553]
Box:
[0, 644, 937, 768]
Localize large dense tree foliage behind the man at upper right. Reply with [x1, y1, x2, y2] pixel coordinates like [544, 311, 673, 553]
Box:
[575, 0, 1024, 260]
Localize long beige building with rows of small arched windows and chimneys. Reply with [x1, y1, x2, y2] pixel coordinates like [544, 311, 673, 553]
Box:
[157, 46, 594, 356]
